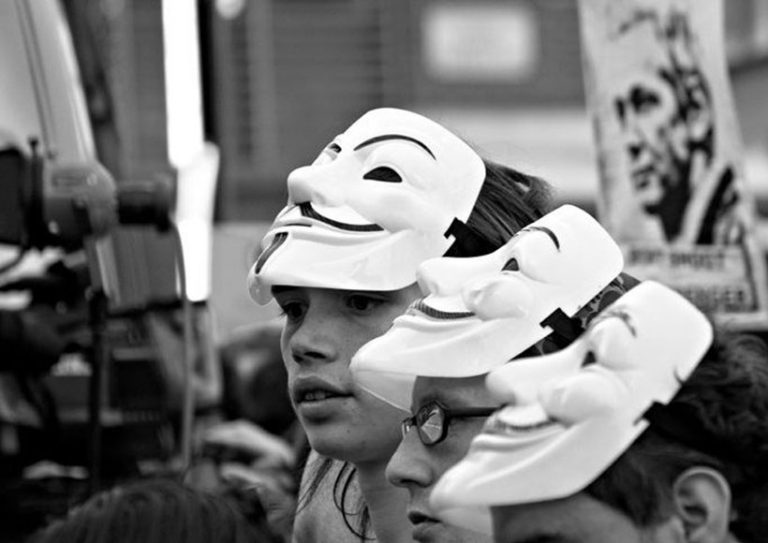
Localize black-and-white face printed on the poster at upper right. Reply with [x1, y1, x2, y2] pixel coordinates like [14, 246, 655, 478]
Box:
[611, 13, 714, 239]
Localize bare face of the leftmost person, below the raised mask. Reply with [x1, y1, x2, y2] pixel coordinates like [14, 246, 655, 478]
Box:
[273, 285, 420, 463]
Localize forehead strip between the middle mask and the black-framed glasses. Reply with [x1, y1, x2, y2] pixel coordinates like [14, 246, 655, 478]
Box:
[411, 375, 495, 409]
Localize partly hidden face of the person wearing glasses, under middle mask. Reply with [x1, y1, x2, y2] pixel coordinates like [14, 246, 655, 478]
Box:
[387, 375, 495, 543]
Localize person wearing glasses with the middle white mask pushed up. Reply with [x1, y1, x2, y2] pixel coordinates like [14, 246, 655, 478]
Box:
[351, 206, 634, 543]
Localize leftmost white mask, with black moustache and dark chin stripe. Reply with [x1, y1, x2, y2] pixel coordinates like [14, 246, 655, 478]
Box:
[249, 108, 485, 302]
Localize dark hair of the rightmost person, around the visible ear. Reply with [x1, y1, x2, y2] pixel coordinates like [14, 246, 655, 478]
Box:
[586, 334, 768, 542]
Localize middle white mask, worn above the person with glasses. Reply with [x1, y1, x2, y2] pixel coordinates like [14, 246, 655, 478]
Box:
[350, 205, 624, 410]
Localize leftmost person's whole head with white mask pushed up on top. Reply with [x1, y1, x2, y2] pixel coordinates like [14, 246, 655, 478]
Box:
[249, 109, 548, 463]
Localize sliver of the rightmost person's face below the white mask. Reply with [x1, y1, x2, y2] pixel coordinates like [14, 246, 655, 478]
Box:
[491, 492, 672, 543]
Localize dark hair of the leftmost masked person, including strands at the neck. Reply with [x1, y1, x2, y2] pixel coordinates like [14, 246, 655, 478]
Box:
[297, 159, 552, 541]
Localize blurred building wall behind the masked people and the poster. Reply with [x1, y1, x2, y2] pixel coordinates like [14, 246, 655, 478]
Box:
[65, 0, 768, 329]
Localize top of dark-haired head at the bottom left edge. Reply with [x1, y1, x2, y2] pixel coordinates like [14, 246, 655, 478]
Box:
[29, 478, 279, 543]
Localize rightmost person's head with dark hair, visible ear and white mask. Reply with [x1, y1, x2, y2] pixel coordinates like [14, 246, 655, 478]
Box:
[432, 282, 768, 543]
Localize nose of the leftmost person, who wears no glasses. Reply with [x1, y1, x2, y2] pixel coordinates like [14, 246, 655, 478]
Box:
[287, 307, 343, 364]
